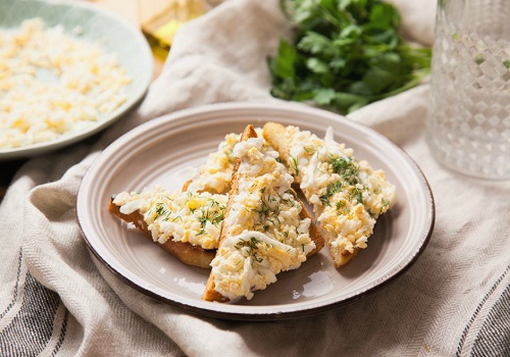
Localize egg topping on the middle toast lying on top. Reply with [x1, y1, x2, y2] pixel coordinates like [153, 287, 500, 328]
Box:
[211, 138, 315, 301]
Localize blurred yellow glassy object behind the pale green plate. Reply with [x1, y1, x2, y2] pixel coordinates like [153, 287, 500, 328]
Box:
[139, 0, 206, 60]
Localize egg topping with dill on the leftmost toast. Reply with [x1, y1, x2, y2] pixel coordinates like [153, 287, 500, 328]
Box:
[113, 187, 227, 249]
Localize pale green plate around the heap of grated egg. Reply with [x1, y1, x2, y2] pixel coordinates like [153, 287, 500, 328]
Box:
[0, 0, 154, 160]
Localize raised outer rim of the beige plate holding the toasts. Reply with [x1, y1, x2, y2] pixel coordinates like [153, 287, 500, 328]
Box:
[76, 101, 436, 321]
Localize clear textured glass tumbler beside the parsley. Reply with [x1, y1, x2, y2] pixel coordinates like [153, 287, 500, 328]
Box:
[427, 0, 510, 179]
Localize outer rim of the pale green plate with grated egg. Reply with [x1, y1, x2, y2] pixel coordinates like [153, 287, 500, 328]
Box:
[0, 0, 155, 161]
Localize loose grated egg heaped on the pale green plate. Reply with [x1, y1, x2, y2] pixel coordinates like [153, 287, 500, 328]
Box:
[0, 18, 131, 149]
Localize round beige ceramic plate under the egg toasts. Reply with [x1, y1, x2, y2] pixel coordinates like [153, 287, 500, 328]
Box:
[77, 103, 434, 320]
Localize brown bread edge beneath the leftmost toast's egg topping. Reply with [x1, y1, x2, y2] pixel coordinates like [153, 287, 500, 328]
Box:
[108, 197, 216, 269]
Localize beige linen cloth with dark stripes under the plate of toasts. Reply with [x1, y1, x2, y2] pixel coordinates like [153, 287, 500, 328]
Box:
[0, 0, 510, 356]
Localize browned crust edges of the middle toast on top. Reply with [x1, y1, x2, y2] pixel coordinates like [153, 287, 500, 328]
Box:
[202, 125, 324, 302]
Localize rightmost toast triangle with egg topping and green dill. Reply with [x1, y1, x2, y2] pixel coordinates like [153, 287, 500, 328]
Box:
[263, 123, 395, 267]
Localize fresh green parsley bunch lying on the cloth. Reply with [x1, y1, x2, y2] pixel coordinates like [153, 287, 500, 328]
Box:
[268, 0, 431, 113]
